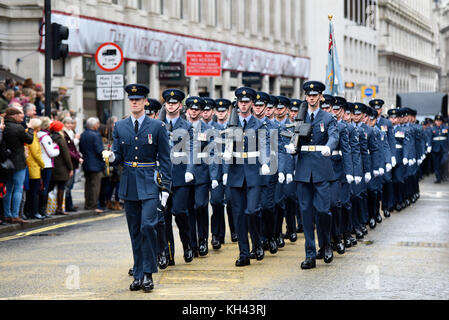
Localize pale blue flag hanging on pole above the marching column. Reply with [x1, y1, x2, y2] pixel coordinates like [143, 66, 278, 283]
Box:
[324, 17, 344, 96]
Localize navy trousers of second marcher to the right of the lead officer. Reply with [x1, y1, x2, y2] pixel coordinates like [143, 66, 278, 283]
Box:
[188, 183, 209, 248]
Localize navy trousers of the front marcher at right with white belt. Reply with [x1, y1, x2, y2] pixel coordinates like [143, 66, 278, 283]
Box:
[297, 181, 331, 259]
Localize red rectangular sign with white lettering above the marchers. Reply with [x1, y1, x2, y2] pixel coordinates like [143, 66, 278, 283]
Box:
[186, 51, 221, 77]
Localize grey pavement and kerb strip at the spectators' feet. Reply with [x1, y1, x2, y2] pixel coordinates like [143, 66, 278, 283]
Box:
[0, 172, 123, 237]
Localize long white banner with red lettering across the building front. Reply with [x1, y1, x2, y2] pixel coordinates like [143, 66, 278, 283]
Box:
[40, 12, 310, 78]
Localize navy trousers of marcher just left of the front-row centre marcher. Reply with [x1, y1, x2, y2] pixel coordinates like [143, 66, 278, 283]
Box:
[210, 183, 226, 240]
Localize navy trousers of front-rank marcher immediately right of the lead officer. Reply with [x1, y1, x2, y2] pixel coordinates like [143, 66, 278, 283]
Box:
[165, 186, 191, 259]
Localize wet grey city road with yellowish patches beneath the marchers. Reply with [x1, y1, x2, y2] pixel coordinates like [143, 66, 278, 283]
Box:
[0, 178, 449, 300]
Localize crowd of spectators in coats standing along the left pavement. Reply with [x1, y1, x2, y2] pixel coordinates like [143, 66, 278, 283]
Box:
[0, 79, 122, 224]
